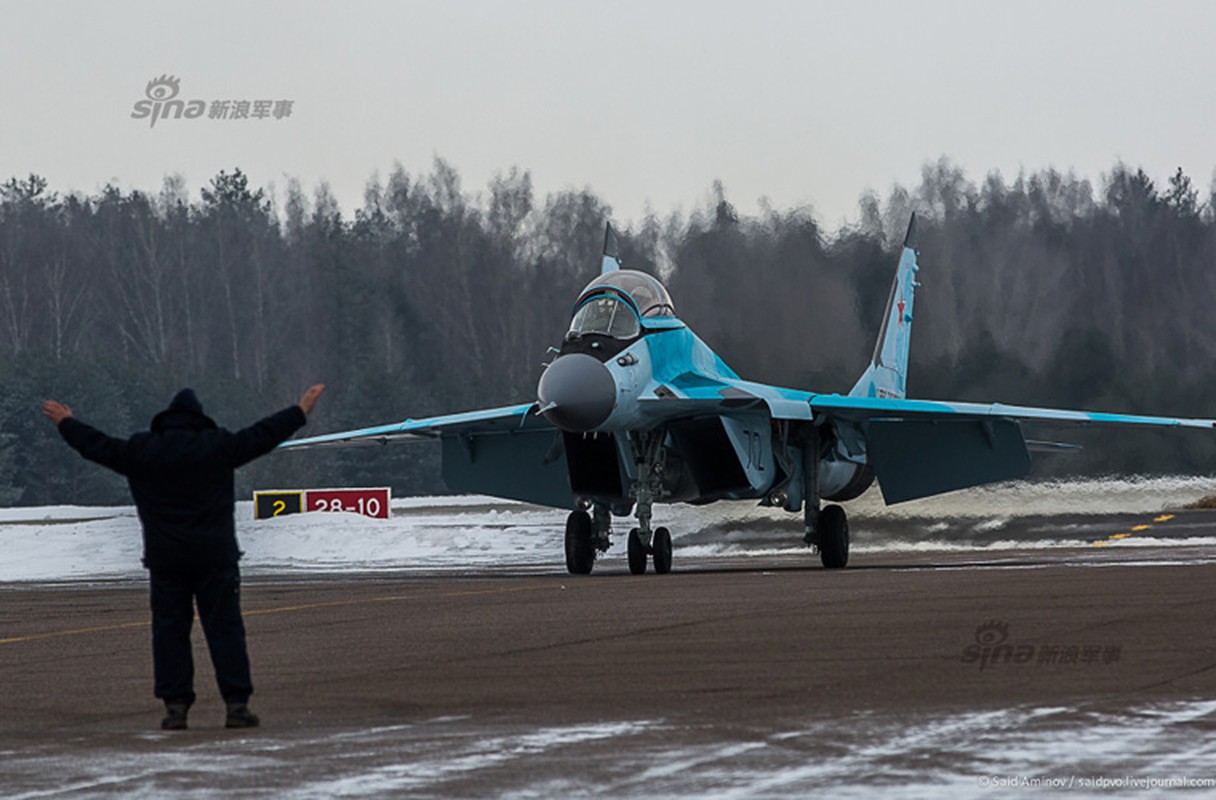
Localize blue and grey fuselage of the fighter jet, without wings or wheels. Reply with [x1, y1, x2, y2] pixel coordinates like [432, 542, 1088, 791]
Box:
[537, 270, 872, 505]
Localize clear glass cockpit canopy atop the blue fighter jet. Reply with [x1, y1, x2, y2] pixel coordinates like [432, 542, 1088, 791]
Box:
[567, 270, 675, 339]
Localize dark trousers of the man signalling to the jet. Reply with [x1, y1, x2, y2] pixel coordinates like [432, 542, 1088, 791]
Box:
[150, 564, 253, 705]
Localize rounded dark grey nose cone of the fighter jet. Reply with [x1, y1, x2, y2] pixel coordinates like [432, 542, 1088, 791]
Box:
[536, 353, 617, 433]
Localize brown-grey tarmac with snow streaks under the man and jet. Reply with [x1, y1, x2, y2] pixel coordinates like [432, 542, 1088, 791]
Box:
[0, 532, 1216, 798]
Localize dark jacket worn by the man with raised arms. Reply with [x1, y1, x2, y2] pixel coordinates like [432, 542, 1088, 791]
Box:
[60, 389, 306, 569]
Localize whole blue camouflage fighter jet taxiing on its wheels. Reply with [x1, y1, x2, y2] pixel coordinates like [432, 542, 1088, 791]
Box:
[281, 215, 1216, 574]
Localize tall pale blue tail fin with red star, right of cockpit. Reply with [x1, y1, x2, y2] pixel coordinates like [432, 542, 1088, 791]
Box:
[849, 214, 921, 398]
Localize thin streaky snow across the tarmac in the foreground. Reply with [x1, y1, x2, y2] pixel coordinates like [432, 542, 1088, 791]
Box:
[0, 699, 1216, 800]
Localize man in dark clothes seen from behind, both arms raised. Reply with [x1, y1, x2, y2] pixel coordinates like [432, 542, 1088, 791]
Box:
[43, 383, 325, 731]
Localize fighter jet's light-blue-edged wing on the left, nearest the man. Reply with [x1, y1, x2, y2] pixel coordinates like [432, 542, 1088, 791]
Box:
[278, 402, 552, 450]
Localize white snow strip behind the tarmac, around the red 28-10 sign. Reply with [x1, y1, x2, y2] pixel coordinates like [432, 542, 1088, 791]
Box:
[0, 477, 1216, 582]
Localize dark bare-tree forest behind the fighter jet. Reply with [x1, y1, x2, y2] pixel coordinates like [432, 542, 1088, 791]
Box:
[0, 159, 1216, 505]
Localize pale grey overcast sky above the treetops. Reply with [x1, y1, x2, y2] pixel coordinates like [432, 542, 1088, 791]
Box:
[0, 0, 1216, 227]
